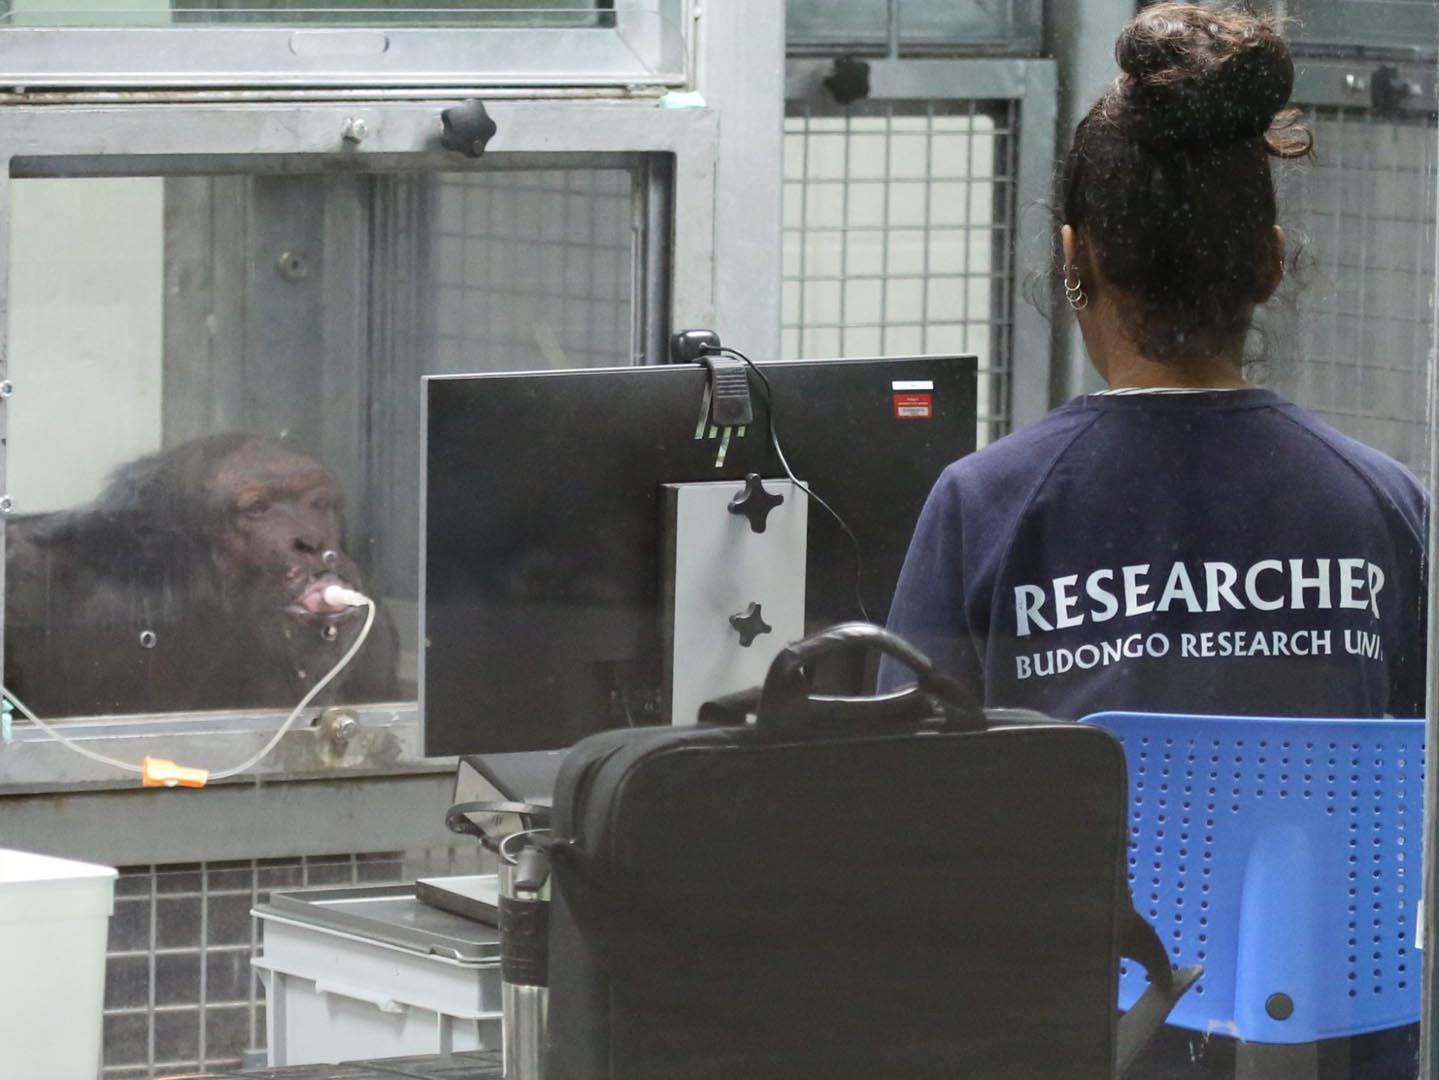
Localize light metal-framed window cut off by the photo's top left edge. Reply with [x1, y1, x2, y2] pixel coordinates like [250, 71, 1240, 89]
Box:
[0, 0, 689, 89]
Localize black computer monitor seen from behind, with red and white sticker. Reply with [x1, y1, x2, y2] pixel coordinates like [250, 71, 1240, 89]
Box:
[420, 355, 976, 755]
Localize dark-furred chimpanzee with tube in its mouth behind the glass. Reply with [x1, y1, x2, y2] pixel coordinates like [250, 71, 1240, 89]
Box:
[4, 434, 397, 719]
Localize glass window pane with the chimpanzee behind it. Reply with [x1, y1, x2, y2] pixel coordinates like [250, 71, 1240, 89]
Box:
[6, 167, 643, 716]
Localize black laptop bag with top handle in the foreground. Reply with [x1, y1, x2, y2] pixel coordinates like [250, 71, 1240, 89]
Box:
[547, 624, 1197, 1080]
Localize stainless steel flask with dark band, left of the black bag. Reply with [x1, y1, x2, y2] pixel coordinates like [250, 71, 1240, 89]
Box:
[499, 830, 550, 1080]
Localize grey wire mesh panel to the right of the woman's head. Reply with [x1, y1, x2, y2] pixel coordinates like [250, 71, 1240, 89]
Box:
[1262, 108, 1435, 475]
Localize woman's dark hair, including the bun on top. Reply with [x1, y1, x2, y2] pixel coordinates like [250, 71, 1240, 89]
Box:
[1061, 3, 1312, 364]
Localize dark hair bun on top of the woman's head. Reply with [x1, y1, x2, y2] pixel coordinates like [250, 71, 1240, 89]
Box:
[1111, 3, 1309, 157]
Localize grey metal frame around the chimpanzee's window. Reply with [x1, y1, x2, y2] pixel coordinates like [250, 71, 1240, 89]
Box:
[0, 101, 718, 793]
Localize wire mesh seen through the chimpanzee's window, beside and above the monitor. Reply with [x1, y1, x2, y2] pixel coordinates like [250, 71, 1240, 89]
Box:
[358, 167, 646, 621]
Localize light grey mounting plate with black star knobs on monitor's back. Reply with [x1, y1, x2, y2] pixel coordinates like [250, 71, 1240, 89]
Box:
[661, 476, 809, 723]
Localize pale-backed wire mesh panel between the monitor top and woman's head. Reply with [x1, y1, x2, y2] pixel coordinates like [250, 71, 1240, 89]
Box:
[783, 101, 1019, 444]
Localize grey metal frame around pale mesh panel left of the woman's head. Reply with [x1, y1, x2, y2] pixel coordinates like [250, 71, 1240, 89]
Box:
[784, 59, 1059, 427]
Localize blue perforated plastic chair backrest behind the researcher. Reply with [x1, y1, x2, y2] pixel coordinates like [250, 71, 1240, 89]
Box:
[1084, 712, 1423, 1043]
